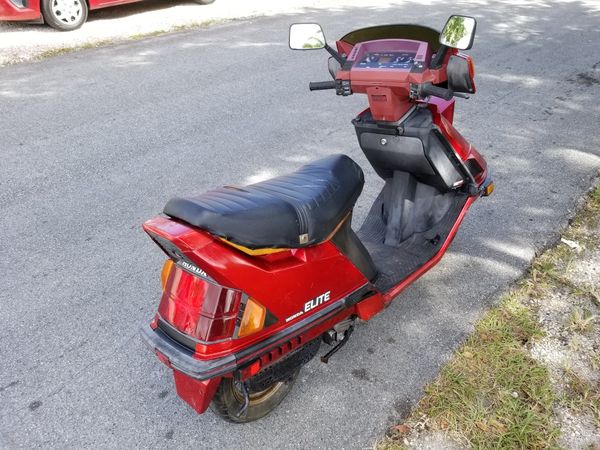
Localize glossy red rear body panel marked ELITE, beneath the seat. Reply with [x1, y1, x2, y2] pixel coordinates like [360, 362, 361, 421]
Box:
[144, 217, 367, 359]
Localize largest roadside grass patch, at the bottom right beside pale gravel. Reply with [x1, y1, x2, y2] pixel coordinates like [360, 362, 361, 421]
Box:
[390, 294, 559, 449]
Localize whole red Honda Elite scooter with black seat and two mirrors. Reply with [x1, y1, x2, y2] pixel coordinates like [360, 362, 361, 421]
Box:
[142, 16, 493, 422]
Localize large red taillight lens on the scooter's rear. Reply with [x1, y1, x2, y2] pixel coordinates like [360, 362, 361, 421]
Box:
[158, 265, 242, 342]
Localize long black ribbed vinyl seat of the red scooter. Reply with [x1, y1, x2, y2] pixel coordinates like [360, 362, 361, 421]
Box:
[164, 155, 364, 249]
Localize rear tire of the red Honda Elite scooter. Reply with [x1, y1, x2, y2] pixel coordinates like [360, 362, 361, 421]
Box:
[210, 368, 300, 423]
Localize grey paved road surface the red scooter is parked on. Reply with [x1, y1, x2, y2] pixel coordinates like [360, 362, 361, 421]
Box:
[0, 0, 600, 449]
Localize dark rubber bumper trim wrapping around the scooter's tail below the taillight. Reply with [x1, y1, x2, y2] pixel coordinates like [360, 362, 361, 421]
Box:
[141, 285, 370, 380]
